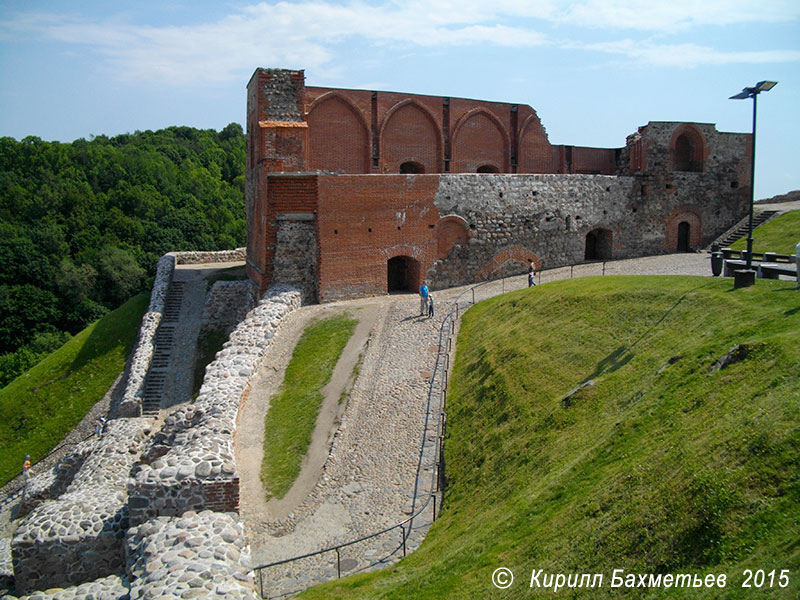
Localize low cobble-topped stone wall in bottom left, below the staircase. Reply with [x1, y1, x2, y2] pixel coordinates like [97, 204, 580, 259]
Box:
[11, 418, 151, 593]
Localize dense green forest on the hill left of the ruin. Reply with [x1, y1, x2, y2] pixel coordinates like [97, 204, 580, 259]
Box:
[0, 123, 245, 386]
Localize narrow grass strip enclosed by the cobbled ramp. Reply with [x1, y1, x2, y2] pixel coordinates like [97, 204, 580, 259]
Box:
[261, 315, 358, 498]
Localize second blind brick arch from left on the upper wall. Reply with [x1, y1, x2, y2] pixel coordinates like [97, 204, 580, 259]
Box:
[380, 99, 443, 173]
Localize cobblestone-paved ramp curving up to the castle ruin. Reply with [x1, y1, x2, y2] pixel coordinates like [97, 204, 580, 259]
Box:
[237, 254, 711, 597]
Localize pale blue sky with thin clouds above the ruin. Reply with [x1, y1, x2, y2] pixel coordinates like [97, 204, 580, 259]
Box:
[0, 0, 800, 199]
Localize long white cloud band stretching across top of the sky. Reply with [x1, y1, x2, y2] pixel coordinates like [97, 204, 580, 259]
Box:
[0, 0, 800, 84]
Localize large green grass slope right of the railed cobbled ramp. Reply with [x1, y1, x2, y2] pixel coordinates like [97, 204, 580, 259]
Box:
[303, 277, 800, 599]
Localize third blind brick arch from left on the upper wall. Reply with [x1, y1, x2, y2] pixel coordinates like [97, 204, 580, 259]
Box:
[452, 108, 509, 173]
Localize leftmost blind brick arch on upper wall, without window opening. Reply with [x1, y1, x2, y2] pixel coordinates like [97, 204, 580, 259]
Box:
[307, 92, 372, 173]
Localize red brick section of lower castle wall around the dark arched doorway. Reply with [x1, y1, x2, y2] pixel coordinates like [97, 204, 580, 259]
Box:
[317, 175, 439, 302]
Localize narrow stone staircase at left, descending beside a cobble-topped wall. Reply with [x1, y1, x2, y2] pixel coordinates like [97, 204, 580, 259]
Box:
[142, 281, 185, 416]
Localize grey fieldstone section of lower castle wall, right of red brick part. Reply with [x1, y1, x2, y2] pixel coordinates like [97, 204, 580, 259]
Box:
[428, 174, 636, 288]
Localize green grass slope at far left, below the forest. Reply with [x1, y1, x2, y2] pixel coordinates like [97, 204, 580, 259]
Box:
[0, 294, 149, 484]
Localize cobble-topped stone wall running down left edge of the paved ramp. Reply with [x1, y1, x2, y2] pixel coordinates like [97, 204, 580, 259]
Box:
[128, 286, 301, 524]
